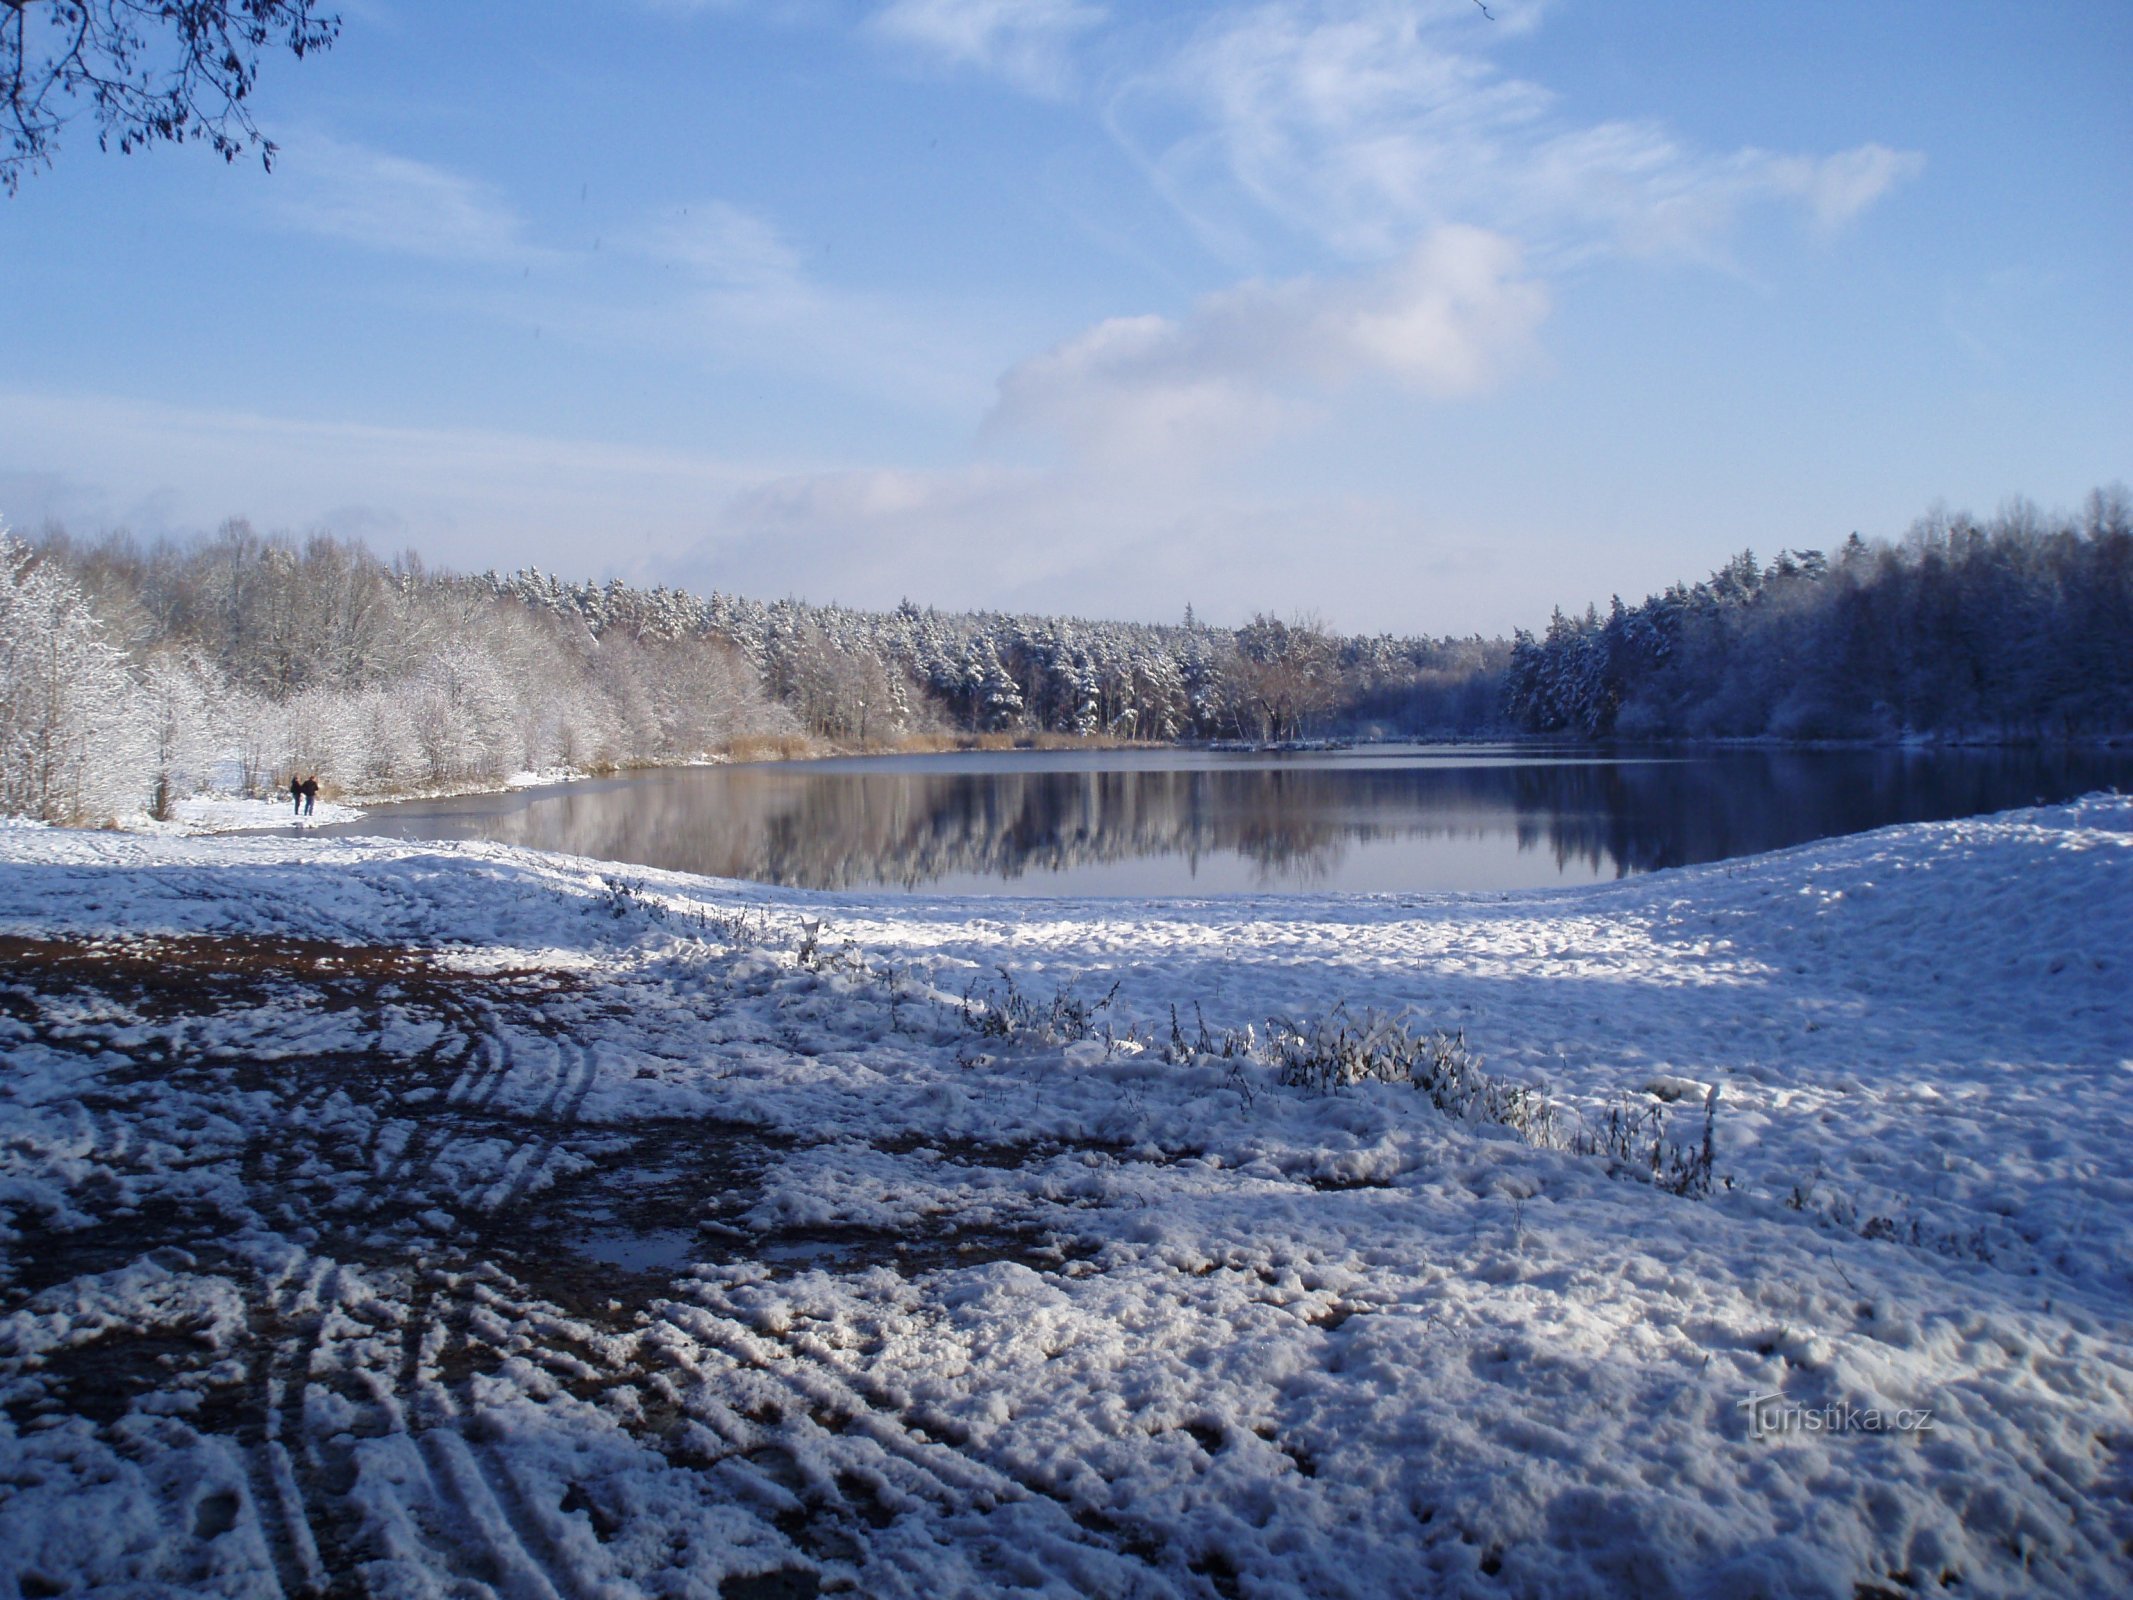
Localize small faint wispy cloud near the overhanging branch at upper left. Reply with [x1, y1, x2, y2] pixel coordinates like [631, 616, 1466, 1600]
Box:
[273, 134, 533, 262]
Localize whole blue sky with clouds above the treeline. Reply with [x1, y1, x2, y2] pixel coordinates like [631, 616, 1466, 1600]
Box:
[0, 0, 2133, 634]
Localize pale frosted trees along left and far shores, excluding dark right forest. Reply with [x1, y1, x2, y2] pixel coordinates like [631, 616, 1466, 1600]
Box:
[0, 523, 1508, 821]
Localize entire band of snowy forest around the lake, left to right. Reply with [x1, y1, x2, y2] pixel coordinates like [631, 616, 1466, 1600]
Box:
[0, 484, 2133, 821]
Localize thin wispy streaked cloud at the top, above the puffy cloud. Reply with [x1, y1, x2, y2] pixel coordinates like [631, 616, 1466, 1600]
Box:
[1107, 0, 1922, 258]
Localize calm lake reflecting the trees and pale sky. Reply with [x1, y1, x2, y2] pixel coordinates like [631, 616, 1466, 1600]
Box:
[331, 745, 2133, 894]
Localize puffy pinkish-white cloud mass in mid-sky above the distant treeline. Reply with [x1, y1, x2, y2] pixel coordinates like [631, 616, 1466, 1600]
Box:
[665, 208, 1549, 627]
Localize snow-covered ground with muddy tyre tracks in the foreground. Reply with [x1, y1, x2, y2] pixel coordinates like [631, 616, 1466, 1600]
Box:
[0, 798, 2133, 1598]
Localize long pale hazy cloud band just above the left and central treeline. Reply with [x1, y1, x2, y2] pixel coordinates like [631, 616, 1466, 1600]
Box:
[0, 390, 1561, 631]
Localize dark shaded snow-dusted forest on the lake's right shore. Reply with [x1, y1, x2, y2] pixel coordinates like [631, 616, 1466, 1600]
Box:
[1508, 484, 2133, 738]
